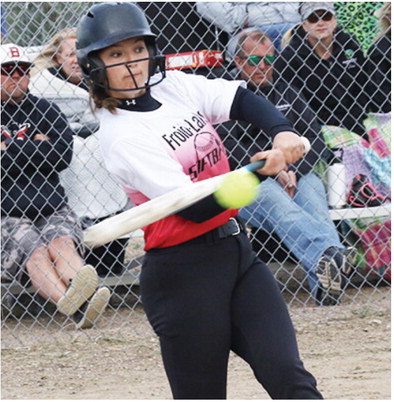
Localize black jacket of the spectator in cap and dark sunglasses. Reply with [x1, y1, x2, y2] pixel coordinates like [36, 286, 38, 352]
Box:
[274, 25, 368, 135]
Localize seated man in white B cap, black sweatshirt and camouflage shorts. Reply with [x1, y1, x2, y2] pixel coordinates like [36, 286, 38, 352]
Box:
[0, 44, 110, 328]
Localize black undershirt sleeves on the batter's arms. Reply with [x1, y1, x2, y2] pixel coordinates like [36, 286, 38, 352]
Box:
[177, 87, 296, 223]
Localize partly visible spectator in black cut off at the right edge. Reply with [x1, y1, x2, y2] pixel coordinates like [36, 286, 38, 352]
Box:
[367, 3, 391, 113]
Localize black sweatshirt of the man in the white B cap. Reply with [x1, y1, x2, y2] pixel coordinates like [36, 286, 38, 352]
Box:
[1, 94, 72, 220]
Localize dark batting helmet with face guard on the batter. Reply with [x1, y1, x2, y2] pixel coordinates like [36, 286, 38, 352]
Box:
[77, 3, 165, 91]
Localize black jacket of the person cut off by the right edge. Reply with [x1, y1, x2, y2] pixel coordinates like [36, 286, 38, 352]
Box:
[367, 32, 391, 113]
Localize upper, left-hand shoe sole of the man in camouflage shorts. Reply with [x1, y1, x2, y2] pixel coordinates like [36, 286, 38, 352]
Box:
[57, 265, 99, 315]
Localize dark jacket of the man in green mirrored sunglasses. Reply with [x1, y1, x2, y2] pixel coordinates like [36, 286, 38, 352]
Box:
[219, 72, 328, 177]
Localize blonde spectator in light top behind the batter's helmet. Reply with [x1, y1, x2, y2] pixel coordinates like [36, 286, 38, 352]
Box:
[30, 28, 98, 137]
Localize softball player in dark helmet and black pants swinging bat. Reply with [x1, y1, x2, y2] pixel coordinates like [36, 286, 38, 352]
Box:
[77, 3, 322, 399]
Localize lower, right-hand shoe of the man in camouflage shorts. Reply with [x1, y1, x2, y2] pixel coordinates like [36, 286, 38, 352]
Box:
[73, 288, 111, 329]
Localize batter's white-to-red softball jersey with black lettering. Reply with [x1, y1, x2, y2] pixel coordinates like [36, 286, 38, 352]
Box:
[98, 71, 245, 249]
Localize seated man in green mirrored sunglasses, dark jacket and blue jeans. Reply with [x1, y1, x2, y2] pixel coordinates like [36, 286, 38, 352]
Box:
[220, 30, 350, 305]
